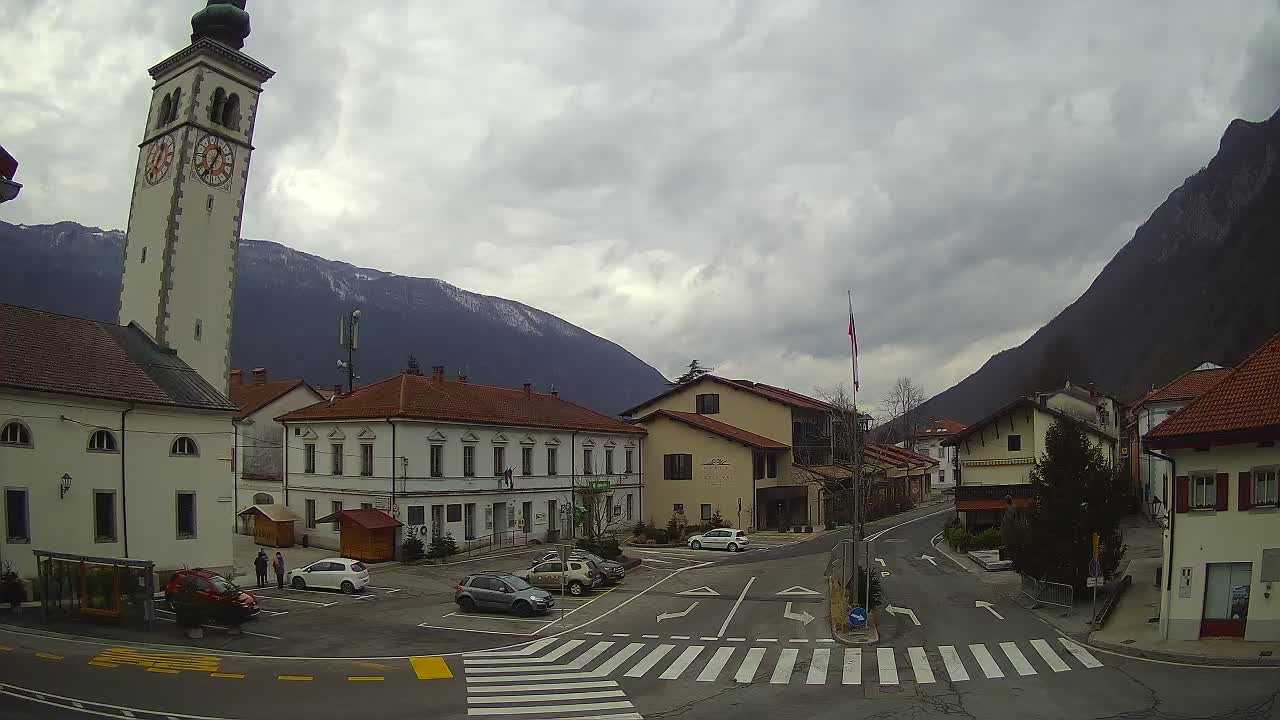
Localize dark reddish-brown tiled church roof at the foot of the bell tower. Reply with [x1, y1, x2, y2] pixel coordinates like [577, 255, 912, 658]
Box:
[0, 304, 234, 410]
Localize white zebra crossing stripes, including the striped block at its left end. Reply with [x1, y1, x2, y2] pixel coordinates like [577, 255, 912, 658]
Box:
[463, 630, 1102, 702]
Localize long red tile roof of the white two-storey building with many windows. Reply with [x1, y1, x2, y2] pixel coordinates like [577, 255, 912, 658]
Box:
[278, 374, 645, 434]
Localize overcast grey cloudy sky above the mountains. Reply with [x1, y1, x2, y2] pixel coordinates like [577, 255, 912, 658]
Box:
[0, 0, 1280, 407]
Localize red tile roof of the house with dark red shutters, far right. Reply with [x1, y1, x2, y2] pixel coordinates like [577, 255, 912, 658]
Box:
[1147, 334, 1280, 447]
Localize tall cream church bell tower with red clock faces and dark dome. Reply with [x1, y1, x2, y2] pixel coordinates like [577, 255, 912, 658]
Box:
[119, 0, 274, 395]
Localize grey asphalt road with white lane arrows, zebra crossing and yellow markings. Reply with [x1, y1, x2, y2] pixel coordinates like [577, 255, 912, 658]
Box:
[0, 499, 1280, 720]
